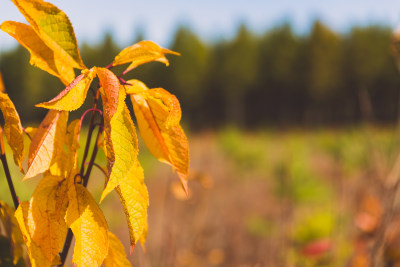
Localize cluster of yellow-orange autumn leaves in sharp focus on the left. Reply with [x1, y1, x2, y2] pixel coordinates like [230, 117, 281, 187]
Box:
[0, 0, 189, 266]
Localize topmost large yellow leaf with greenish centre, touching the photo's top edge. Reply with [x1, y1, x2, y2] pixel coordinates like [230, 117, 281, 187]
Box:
[12, 0, 86, 69]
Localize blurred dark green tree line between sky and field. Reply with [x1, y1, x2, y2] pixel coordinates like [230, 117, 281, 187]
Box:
[0, 21, 400, 130]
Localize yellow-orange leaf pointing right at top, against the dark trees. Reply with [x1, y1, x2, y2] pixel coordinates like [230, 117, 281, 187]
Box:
[112, 41, 179, 73]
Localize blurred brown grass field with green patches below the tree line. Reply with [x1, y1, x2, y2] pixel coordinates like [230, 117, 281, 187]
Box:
[0, 128, 400, 267]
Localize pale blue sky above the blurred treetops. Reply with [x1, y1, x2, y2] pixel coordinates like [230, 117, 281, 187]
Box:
[0, 0, 400, 51]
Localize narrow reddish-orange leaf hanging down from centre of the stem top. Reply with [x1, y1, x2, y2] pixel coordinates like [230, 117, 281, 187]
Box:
[96, 68, 120, 119]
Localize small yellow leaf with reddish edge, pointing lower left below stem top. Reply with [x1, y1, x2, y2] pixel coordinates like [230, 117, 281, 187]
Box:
[36, 68, 95, 111]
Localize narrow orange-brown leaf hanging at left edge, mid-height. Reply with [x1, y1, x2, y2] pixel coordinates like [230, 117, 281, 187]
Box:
[0, 93, 25, 173]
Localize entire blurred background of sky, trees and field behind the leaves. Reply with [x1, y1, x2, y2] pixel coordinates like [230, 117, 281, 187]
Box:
[0, 0, 400, 267]
